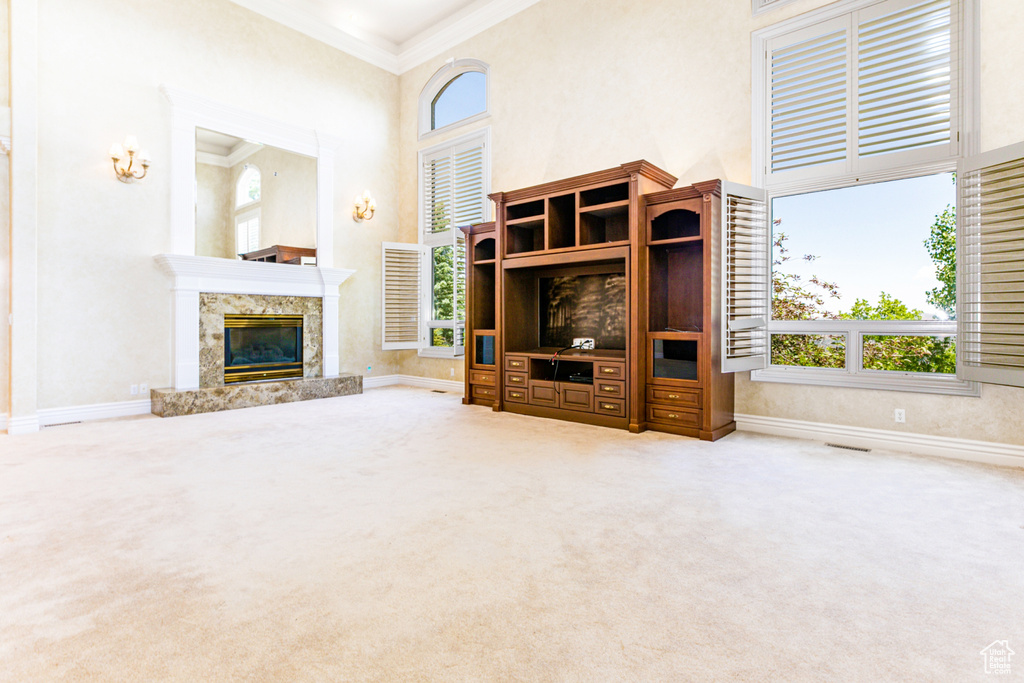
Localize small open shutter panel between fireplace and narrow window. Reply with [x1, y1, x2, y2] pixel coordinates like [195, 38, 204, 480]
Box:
[381, 242, 427, 350]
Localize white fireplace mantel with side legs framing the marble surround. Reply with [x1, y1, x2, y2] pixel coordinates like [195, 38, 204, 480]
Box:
[155, 254, 355, 389]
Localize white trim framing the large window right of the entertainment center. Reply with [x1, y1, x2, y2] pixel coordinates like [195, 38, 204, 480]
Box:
[751, 0, 981, 396]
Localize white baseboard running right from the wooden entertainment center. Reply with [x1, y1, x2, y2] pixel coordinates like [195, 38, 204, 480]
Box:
[735, 415, 1024, 467]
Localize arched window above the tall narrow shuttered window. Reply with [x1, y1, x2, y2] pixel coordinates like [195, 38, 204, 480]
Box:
[420, 59, 487, 137]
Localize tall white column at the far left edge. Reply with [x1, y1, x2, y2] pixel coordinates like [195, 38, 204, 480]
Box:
[7, 0, 39, 434]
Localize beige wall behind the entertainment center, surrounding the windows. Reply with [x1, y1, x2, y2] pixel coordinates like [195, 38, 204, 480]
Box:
[400, 0, 1024, 443]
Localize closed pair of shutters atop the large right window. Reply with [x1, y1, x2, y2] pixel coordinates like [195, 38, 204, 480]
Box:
[755, 0, 959, 188]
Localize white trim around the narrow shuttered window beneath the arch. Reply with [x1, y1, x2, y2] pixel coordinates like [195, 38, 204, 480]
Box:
[416, 129, 492, 358]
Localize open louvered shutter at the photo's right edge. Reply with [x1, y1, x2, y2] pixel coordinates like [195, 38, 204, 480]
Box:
[956, 143, 1024, 386]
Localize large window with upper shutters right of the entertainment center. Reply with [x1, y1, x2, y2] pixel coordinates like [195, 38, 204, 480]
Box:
[753, 0, 977, 393]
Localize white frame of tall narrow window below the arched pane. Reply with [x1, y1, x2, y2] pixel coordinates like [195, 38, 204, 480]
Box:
[417, 129, 492, 358]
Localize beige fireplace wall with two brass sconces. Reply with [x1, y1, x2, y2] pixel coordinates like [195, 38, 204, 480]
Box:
[38, 0, 399, 409]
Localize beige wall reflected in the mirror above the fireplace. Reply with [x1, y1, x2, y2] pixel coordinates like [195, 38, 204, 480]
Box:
[231, 147, 316, 249]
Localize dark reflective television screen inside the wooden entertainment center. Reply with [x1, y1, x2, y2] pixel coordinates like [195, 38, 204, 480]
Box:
[540, 272, 627, 349]
